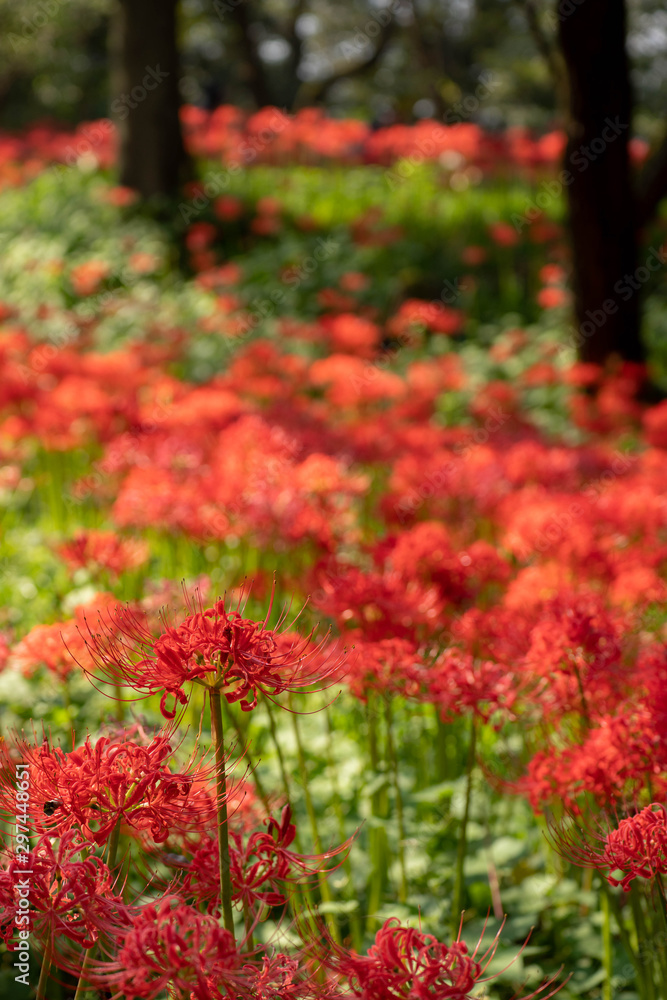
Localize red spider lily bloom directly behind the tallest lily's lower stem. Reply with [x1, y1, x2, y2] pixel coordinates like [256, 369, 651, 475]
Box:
[178, 806, 349, 917]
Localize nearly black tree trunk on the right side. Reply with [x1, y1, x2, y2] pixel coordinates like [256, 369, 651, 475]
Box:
[558, 0, 644, 364]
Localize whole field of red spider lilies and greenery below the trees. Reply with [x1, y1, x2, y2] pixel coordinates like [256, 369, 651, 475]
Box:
[0, 108, 667, 1000]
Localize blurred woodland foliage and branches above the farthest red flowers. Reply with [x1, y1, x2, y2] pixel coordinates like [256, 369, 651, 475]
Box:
[0, 0, 667, 138]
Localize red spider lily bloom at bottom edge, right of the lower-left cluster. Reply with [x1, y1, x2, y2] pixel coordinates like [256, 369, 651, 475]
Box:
[326, 917, 556, 1000]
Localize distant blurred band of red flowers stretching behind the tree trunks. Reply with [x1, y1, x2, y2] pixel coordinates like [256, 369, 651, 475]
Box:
[0, 104, 648, 183]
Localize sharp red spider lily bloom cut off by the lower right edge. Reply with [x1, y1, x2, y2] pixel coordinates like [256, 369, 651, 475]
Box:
[554, 802, 667, 892]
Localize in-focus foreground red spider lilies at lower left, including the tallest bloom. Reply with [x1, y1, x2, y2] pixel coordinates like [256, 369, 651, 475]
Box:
[0, 588, 552, 1000]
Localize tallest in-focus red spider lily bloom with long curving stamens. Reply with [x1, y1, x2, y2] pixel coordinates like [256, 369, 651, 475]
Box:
[81, 585, 348, 718]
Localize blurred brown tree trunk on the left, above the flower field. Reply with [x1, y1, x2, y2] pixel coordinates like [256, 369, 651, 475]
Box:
[111, 0, 187, 198]
